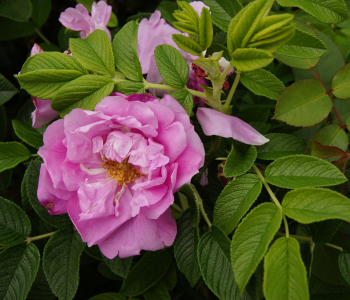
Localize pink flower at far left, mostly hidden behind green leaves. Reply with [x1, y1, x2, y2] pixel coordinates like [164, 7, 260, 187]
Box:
[30, 44, 58, 128]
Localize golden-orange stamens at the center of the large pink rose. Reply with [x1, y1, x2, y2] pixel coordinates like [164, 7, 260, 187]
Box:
[102, 157, 145, 186]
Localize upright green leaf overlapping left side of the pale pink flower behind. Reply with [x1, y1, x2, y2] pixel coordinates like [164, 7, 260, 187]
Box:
[113, 21, 143, 81]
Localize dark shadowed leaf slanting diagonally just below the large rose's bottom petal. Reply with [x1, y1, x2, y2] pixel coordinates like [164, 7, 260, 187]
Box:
[120, 250, 172, 297]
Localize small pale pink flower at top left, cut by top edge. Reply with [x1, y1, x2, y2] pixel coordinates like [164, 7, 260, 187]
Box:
[58, 0, 112, 39]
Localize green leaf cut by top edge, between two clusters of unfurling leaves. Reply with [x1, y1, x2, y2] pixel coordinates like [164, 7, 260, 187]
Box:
[203, 0, 242, 32]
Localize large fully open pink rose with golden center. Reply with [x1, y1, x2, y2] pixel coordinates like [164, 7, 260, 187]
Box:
[38, 94, 204, 259]
